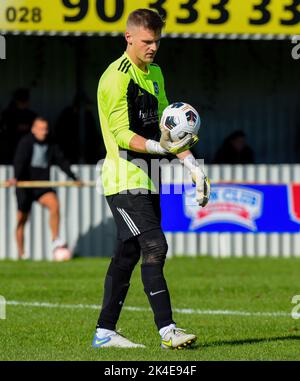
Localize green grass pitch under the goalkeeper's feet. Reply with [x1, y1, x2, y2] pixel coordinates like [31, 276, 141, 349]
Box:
[0, 257, 300, 361]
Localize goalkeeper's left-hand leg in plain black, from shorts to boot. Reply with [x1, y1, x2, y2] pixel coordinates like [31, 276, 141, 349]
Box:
[97, 238, 140, 331]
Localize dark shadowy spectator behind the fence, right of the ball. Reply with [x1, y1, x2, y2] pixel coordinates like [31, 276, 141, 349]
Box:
[214, 130, 254, 164]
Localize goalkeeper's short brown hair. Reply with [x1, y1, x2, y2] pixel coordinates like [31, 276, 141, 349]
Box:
[127, 8, 165, 31]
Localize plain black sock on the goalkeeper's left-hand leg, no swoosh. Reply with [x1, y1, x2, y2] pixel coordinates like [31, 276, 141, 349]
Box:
[97, 259, 131, 331]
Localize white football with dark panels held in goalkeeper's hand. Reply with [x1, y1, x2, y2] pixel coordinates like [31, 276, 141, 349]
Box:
[160, 102, 201, 142]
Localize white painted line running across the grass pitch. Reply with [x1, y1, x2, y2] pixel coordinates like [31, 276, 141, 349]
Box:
[6, 300, 300, 319]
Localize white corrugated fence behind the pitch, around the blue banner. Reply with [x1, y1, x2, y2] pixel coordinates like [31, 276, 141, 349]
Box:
[0, 164, 300, 260]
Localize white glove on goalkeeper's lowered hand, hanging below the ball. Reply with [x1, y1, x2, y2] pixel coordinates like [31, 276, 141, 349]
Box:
[181, 154, 210, 207]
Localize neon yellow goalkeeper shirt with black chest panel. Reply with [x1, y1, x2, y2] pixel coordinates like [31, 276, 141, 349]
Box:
[98, 52, 168, 196]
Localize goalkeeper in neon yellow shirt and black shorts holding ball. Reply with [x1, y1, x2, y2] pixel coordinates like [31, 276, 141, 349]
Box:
[93, 9, 209, 349]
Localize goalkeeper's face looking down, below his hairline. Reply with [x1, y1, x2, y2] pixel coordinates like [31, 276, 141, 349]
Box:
[125, 27, 161, 64]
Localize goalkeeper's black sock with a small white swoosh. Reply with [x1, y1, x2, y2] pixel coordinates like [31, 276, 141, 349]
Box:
[141, 264, 174, 329]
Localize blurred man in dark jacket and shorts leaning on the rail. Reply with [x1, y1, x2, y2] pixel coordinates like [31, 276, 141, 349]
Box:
[9, 117, 81, 259]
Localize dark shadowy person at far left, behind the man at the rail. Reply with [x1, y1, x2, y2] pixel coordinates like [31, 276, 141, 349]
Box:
[0, 88, 37, 164]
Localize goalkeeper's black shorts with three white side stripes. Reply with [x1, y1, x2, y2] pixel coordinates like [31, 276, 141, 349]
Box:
[106, 193, 161, 242]
